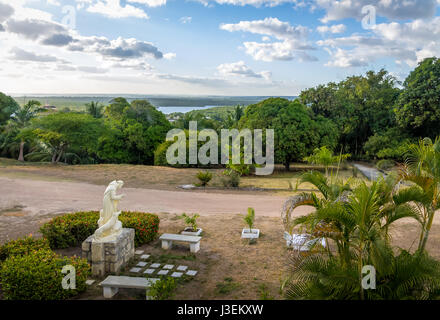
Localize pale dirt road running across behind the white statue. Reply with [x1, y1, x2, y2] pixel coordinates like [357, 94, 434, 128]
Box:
[0, 177, 307, 242]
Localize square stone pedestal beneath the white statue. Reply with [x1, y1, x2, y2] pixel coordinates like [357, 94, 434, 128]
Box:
[82, 228, 134, 277]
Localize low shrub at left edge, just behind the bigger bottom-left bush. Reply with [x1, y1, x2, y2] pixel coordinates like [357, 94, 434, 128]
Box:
[0, 236, 50, 262]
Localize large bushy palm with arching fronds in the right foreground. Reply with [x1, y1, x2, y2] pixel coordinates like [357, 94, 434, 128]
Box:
[285, 172, 419, 299]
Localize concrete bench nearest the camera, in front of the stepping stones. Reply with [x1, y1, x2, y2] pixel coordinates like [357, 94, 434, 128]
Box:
[99, 276, 159, 298]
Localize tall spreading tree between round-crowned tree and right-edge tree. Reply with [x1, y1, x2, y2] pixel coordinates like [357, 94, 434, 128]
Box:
[300, 70, 400, 157]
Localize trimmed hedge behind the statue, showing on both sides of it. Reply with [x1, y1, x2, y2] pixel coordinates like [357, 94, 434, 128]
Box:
[40, 211, 160, 249]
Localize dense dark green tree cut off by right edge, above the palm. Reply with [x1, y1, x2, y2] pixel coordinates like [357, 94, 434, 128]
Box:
[395, 58, 440, 138]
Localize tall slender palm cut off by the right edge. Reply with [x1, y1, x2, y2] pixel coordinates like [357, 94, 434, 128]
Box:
[400, 137, 440, 251]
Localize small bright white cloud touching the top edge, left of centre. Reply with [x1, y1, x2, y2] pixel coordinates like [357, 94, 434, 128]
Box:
[87, 0, 149, 19]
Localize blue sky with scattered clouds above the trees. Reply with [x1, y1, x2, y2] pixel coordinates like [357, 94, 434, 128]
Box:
[0, 0, 440, 96]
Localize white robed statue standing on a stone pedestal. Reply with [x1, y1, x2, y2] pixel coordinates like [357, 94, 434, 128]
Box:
[94, 180, 125, 242]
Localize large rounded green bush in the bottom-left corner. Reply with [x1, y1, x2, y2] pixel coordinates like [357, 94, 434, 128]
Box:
[0, 249, 90, 300]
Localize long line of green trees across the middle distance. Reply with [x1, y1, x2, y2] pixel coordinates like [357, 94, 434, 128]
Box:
[0, 57, 440, 169]
